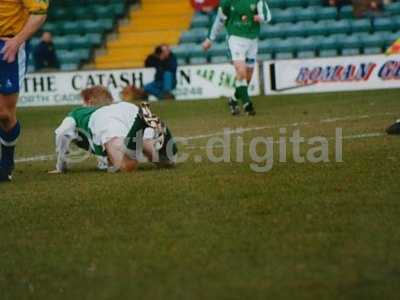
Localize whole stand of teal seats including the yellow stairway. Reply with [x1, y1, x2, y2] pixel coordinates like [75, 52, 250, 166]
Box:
[29, 0, 400, 71]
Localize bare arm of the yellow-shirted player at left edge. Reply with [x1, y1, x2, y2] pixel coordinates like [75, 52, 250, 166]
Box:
[1, 15, 46, 63]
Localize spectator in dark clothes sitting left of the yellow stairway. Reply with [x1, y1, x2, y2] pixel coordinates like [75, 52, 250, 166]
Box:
[33, 32, 60, 71]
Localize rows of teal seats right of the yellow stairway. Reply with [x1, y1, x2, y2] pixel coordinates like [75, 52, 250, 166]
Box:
[174, 0, 400, 64]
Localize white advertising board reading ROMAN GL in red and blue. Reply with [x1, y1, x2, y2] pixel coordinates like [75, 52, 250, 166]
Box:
[263, 55, 400, 95]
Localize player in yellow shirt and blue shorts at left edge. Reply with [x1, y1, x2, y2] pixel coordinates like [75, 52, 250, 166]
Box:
[0, 0, 49, 182]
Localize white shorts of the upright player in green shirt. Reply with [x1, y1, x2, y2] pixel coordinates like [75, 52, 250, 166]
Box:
[228, 35, 258, 66]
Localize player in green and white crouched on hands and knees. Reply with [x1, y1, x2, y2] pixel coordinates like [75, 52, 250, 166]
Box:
[50, 87, 177, 173]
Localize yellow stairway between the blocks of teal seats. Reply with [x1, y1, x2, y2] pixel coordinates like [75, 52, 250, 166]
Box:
[95, 0, 193, 69]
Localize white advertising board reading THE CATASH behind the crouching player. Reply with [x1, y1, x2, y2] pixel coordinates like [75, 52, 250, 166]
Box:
[18, 64, 260, 107]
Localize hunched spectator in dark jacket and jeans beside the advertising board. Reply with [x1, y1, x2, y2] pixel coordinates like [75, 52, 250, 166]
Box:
[144, 45, 178, 99]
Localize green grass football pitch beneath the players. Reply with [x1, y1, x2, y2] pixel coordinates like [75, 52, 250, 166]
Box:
[0, 90, 400, 299]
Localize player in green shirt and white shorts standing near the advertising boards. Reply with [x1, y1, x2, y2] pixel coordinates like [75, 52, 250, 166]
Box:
[203, 0, 271, 115]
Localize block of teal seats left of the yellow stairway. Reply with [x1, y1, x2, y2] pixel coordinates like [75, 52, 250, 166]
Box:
[29, 0, 129, 71]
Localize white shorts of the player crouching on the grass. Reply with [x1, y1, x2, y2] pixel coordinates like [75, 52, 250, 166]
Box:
[89, 102, 139, 146]
